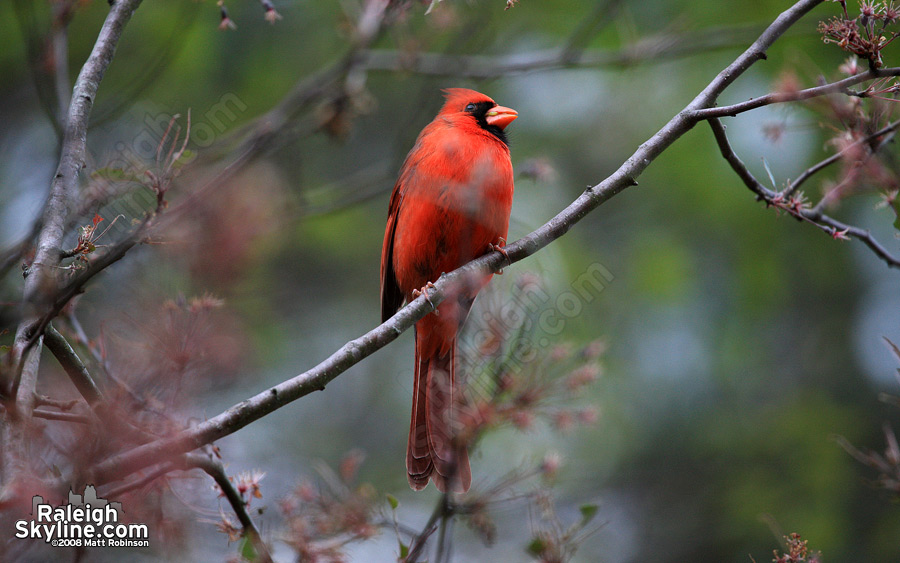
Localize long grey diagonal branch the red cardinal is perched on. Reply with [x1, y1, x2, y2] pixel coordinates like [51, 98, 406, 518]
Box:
[91, 0, 822, 483]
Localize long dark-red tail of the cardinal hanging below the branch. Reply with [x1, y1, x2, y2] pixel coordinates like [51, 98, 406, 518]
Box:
[406, 331, 472, 492]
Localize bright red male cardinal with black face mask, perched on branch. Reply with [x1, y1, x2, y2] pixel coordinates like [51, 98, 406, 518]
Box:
[381, 88, 518, 492]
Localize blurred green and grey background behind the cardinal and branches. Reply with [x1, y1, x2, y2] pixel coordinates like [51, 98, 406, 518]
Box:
[0, 0, 900, 562]
